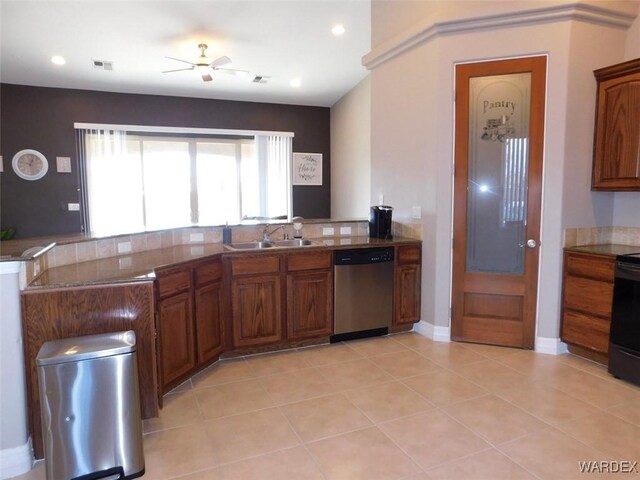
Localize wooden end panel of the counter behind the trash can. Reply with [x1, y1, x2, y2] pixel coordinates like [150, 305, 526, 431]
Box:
[21, 282, 158, 458]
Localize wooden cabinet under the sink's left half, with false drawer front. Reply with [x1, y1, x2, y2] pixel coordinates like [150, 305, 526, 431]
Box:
[229, 255, 282, 348]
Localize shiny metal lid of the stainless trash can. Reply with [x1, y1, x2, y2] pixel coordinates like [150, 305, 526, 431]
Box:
[36, 330, 136, 367]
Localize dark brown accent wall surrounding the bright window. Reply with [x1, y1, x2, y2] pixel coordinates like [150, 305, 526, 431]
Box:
[0, 84, 331, 238]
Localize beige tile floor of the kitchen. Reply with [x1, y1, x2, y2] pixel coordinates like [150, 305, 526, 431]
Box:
[17, 333, 640, 480]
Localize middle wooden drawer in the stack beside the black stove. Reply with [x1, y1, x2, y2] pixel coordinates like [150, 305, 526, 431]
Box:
[564, 275, 613, 318]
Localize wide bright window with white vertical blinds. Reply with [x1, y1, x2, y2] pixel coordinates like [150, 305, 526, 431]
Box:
[79, 124, 292, 235]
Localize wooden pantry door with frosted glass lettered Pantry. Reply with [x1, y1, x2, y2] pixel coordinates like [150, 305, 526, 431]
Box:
[451, 56, 546, 348]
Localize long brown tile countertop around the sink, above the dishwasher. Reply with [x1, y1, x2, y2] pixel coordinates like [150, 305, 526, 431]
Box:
[27, 237, 421, 289]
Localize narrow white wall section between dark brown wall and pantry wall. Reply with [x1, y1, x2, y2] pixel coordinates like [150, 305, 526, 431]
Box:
[331, 76, 372, 219]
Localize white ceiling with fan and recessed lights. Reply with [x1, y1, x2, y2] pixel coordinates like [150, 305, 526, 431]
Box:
[0, 0, 371, 107]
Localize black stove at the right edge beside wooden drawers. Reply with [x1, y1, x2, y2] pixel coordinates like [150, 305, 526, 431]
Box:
[609, 253, 640, 386]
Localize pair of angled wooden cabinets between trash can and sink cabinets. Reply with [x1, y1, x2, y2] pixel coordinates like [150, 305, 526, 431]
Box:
[156, 258, 224, 395]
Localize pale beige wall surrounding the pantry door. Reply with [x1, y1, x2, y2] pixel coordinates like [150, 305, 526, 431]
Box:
[365, 1, 633, 338]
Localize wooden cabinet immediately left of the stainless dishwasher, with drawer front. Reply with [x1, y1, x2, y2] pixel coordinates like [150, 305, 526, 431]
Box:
[287, 251, 333, 340]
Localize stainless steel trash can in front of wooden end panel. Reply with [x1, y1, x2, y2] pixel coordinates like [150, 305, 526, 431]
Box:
[36, 331, 144, 480]
